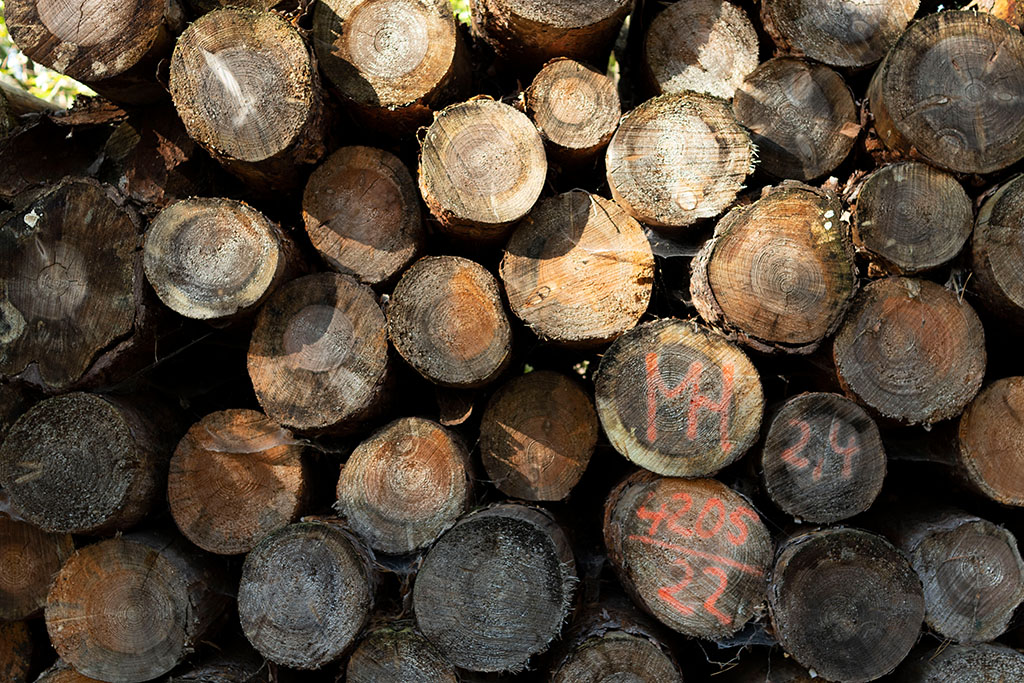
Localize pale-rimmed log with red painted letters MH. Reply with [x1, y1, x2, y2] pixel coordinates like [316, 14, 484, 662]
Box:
[595, 318, 764, 476]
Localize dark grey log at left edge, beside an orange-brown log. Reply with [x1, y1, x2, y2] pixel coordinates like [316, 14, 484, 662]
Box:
[0, 393, 170, 533]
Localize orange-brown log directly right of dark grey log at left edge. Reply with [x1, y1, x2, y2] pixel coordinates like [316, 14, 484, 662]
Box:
[167, 410, 311, 555]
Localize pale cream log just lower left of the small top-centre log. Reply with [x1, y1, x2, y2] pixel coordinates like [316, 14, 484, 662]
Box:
[419, 99, 548, 242]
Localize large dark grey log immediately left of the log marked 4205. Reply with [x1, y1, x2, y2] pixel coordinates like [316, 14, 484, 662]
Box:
[413, 503, 577, 672]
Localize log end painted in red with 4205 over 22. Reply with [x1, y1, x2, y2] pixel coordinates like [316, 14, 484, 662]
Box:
[604, 472, 772, 639]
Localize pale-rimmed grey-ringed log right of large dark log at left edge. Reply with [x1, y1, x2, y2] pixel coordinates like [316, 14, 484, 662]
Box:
[142, 199, 297, 319]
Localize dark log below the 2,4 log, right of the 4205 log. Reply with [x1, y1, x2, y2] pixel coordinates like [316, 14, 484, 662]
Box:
[768, 528, 925, 683]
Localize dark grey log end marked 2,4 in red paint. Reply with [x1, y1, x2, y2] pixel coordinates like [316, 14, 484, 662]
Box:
[761, 393, 886, 524]
